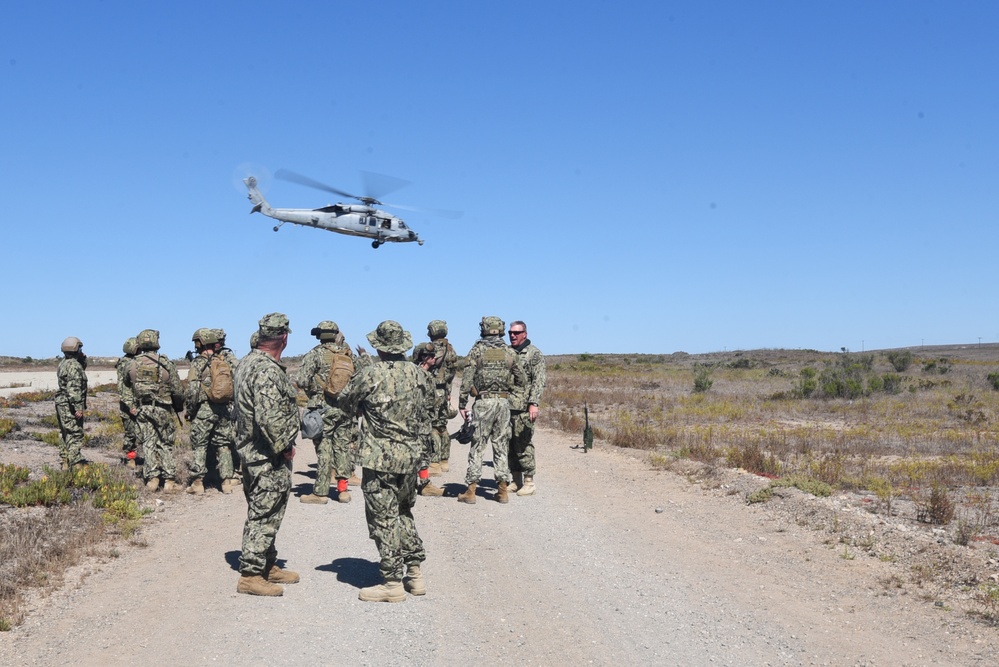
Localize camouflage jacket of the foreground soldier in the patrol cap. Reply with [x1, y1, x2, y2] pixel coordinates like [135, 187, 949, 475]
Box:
[233, 350, 300, 464]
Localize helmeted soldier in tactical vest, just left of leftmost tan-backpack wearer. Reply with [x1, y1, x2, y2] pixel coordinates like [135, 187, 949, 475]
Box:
[122, 329, 184, 493]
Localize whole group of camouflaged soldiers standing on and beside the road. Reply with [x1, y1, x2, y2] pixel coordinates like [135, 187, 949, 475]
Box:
[56, 313, 546, 602]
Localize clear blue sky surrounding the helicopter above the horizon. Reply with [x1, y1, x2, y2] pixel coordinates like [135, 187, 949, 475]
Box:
[0, 0, 999, 357]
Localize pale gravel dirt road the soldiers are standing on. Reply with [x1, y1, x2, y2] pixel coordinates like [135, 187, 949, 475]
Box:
[0, 422, 999, 666]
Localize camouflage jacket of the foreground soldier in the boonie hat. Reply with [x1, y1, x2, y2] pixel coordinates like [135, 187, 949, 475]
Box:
[338, 355, 435, 474]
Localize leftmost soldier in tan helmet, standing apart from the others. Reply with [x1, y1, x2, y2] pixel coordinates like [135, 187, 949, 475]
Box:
[55, 336, 87, 470]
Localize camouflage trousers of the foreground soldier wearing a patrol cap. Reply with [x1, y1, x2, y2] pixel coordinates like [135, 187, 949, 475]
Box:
[239, 454, 291, 576]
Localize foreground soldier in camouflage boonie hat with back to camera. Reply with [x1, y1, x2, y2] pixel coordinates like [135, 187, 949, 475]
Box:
[339, 320, 433, 602]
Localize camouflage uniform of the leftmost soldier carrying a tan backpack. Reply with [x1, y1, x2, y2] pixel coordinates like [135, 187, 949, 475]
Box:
[185, 352, 236, 481]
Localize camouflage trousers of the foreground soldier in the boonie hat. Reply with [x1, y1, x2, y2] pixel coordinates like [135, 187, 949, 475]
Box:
[361, 468, 427, 581]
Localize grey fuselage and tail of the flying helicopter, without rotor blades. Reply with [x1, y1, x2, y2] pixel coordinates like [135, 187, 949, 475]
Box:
[243, 176, 423, 248]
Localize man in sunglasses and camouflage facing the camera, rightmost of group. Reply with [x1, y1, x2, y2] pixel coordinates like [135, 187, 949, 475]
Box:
[509, 320, 548, 496]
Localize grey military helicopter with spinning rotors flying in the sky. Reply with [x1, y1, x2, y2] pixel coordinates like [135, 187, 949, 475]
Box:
[243, 169, 460, 248]
